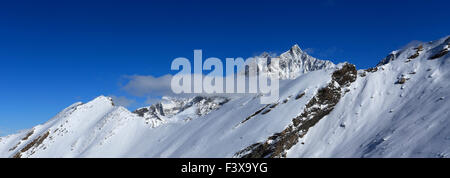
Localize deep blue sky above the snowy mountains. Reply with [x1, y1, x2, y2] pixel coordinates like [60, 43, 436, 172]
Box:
[0, 0, 450, 135]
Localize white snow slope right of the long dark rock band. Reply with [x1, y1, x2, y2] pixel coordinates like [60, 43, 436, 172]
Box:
[288, 37, 450, 157]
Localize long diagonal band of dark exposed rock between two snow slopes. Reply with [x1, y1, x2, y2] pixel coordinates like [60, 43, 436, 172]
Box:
[235, 64, 357, 158]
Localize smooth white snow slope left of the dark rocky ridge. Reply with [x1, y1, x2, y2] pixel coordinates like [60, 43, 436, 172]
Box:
[0, 70, 330, 157]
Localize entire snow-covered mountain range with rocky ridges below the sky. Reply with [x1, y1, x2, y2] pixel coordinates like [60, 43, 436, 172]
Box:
[0, 36, 450, 158]
